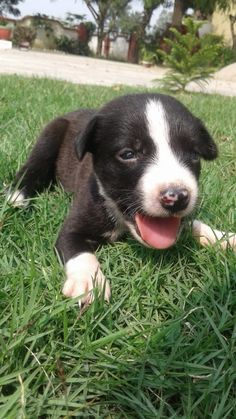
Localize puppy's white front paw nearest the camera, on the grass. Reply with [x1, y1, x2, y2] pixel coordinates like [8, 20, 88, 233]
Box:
[62, 253, 111, 304]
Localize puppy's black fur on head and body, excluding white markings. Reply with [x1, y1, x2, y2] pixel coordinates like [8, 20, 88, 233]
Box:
[14, 94, 217, 262]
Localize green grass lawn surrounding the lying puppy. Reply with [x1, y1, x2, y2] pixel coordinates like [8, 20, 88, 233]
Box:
[0, 76, 236, 419]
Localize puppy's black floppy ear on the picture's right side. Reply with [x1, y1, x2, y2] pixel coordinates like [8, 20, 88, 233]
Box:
[195, 118, 218, 160]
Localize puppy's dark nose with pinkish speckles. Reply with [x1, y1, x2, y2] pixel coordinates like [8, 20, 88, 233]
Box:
[160, 188, 189, 212]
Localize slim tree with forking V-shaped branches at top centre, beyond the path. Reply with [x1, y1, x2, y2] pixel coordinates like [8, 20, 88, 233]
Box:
[84, 0, 131, 56]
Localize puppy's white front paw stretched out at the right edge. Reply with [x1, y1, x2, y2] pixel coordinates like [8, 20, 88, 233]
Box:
[192, 220, 236, 252]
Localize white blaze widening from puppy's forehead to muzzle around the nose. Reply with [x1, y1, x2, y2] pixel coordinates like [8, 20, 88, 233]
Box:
[139, 100, 198, 216]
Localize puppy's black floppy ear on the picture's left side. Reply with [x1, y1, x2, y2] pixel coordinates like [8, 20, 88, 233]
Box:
[75, 115, 98, 161]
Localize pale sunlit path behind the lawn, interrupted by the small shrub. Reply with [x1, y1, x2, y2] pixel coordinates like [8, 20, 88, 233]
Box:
[0, 49, 236, 96]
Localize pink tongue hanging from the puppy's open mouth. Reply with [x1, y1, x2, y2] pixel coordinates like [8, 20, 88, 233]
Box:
[135, 214, 181, 249]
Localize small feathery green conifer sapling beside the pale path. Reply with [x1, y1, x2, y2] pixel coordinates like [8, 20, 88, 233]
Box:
[158, 18, 230, 90]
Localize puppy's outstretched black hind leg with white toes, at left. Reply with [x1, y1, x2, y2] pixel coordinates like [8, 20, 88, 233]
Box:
[8, 118, 68, 207]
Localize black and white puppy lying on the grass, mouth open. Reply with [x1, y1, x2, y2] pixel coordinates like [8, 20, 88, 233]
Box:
[9, 94, 235, 302]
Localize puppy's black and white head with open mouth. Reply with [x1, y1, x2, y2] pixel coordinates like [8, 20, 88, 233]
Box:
[76, 94, 217, 248]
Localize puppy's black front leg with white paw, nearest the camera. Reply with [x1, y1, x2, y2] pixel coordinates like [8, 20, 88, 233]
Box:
[56, 197, 114, 304]
